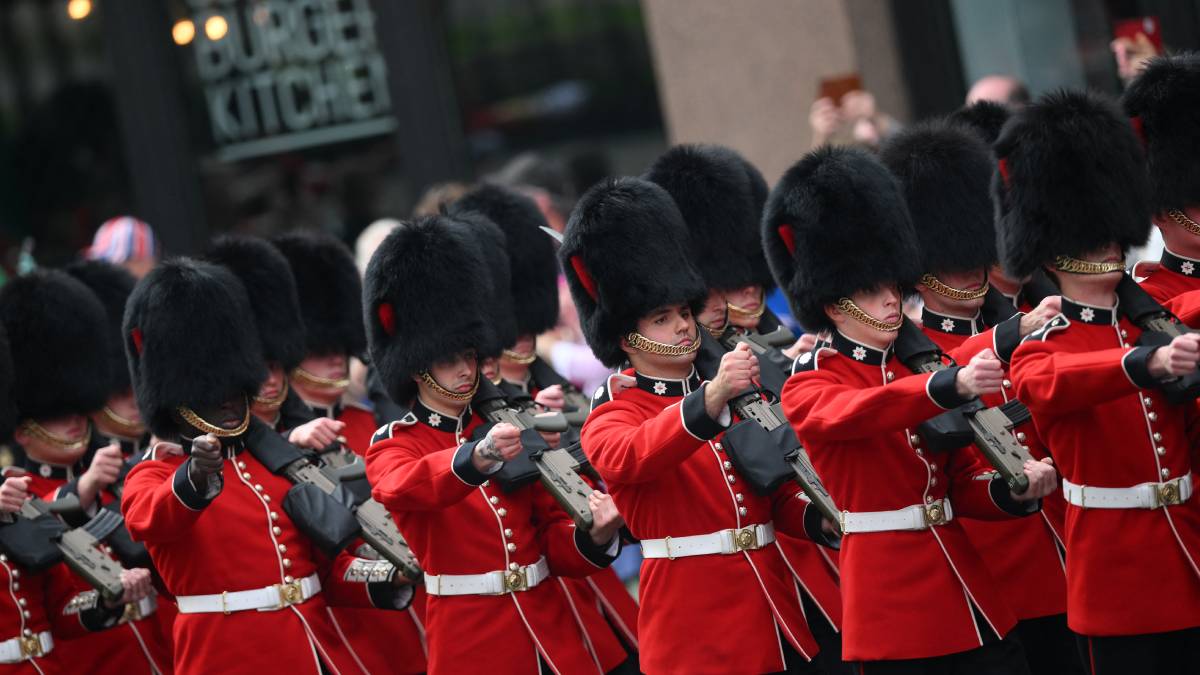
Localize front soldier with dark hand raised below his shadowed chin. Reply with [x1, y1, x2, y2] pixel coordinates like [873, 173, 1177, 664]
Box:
[122, 258, 412, 674]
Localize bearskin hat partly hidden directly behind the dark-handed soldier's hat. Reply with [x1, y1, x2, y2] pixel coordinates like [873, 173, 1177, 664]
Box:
[204, 235, 305, 372]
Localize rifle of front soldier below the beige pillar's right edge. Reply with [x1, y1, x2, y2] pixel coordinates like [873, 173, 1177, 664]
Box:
[894, 318, 1033, 494]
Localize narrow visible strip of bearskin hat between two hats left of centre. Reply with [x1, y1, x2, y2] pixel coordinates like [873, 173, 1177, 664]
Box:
[446, 211, 516, 357]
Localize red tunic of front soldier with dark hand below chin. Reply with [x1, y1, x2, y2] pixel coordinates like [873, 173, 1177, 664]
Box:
[122, 441, 388, 674]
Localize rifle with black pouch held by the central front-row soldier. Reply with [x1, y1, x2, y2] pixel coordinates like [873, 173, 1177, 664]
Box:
[696, 329, 841, 536]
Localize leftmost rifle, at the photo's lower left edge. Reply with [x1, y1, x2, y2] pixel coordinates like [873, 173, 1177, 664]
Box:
[20, 495, 125, 603]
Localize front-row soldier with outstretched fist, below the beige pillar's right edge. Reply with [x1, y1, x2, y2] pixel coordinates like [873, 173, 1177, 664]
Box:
[763, 148, 1055, 673]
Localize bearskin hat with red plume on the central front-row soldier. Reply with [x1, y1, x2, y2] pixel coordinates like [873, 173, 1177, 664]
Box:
[558, 178, 708, 368]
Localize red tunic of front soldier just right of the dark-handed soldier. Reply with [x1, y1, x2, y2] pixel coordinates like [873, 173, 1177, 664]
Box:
[367, 404, 611, 674]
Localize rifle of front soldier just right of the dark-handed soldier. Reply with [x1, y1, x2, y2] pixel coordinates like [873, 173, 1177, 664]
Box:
[470, 380, 593, 532]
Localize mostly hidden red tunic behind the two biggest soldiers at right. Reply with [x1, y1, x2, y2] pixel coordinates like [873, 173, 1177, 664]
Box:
[923, 312, 1067, 620]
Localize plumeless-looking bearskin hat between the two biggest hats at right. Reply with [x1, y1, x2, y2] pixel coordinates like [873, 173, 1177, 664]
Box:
[880, 121, 996, 276]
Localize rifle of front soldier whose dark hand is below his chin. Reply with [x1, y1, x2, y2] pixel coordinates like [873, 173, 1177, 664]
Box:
[247, 420, 422, 581]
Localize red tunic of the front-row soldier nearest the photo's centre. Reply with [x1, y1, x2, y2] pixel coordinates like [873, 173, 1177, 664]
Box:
[582, 371, 817, 673]
